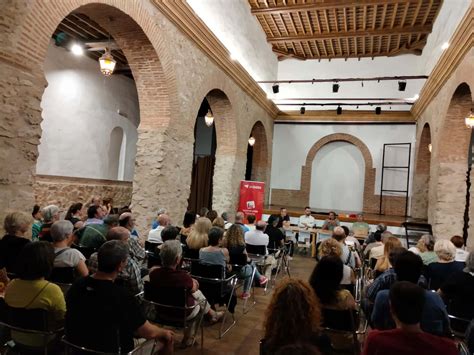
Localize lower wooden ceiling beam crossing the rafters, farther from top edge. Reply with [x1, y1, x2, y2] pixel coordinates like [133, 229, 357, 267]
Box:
[267, 26, 432, 43]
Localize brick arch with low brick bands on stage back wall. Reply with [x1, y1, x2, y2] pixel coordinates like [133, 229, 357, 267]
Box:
[272, 133, 405, 216]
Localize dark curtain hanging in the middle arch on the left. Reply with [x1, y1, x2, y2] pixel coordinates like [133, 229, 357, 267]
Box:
[188, 156, 216, 212]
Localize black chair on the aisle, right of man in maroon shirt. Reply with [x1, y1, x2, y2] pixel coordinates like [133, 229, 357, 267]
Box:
[191, 262, 237, 339]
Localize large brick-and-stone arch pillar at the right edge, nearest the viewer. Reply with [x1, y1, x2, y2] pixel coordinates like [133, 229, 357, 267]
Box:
[430, 83, 473, 242]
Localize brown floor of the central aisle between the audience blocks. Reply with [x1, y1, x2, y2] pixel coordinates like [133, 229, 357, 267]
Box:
[176, 255, 315, 355]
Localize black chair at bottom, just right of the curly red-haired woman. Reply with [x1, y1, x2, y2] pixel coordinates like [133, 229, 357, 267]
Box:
[321, 307, 368, 354]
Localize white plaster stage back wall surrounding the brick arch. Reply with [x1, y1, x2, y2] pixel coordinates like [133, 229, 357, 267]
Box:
[271, 123, 416, 208]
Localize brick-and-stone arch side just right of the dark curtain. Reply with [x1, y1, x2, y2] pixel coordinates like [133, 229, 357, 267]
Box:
[206, 89, 238, 211]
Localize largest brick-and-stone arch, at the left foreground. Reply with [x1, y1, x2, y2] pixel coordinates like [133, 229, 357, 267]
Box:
[0, 0, 178, 235]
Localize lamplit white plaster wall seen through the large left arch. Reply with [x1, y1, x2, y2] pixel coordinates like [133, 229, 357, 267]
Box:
[36, 43, 140, 181]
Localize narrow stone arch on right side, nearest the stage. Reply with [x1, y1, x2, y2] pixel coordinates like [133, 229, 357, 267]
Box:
[411, 123, 433, 219]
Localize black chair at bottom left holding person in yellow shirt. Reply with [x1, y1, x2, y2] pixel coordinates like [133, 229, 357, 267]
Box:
[0, 299, 64, 355]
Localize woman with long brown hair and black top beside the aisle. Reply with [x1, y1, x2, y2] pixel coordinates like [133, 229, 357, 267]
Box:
[226, 225, 267, 299]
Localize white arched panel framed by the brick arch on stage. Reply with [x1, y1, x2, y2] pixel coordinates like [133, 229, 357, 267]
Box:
[309, 142, 365, 211]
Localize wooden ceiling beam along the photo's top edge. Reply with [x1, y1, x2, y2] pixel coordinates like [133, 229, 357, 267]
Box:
[251, 0, 415, 15]
